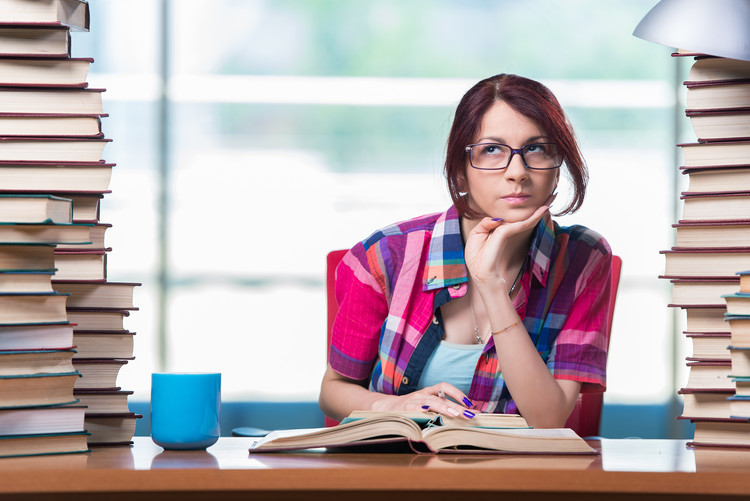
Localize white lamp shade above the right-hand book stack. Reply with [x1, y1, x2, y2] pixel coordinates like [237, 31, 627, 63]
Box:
[633, 0, 750, 61]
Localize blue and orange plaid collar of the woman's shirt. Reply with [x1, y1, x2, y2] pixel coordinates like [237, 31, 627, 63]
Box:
[422, 206, 555, 291]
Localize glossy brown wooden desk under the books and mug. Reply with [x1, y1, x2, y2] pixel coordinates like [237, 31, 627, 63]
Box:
[0, 437, 750, 501]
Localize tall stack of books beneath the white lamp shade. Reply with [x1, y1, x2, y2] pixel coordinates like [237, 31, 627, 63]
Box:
[662, 51, 750, 446]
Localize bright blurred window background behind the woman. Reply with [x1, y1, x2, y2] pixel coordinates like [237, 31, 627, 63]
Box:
[73, 0, 694, 438]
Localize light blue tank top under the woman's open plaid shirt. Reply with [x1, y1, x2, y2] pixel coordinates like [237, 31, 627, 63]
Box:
[417, 341, 484, 395]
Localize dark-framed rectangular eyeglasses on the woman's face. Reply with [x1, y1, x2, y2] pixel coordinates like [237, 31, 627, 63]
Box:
[466, 143, 562, 170]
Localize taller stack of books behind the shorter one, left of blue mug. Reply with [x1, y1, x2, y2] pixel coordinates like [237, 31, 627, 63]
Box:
[0, 0, 140, 446]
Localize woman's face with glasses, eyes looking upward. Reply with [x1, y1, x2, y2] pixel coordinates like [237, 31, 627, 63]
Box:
[466, 101, 560, 222]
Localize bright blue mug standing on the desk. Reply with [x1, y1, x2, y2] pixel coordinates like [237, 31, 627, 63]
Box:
[151, 373, 221, 450]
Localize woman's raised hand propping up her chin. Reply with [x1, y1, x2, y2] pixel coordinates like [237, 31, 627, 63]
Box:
[464, 194, 557, 283]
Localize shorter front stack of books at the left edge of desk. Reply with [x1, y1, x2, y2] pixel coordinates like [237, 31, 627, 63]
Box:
[0, 194, 89, 457]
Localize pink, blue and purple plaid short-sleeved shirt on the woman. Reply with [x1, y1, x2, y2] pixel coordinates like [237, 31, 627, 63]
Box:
[329, 207, 612, 413]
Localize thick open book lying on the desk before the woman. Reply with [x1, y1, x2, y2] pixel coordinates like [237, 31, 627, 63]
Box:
[250, 411, 596, 454]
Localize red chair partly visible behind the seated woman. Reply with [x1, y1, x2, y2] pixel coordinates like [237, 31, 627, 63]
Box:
[325, 250, 622, 437]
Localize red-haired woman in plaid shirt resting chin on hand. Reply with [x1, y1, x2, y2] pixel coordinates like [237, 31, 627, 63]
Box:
[320, 75, 612, 428]
